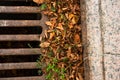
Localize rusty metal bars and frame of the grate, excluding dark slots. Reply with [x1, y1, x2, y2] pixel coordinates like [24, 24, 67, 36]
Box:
[0, 0, 48, 80]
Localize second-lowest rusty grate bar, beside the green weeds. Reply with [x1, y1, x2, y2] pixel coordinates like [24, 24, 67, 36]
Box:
[0, 62, 37, 70]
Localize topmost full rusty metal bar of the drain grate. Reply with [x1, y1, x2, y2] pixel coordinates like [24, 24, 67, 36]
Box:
[0, 6, 40, 13]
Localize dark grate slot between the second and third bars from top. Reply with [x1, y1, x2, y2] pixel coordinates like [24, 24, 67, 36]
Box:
[0, 26, 42, 35]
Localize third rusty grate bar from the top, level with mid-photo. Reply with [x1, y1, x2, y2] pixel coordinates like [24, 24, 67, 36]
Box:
[0, 34, 40, 41]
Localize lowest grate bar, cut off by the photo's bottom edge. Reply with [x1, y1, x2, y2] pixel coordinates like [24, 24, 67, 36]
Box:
[0, 76, 46, 80]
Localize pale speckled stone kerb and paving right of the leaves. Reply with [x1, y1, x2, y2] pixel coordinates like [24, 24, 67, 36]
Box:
[81, 0, 120, 80]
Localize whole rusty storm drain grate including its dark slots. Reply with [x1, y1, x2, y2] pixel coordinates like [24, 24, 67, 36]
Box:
[0, 0, 47, 80]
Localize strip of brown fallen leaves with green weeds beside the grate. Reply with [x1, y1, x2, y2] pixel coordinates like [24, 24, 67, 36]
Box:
[33, 0, 83, 80]
